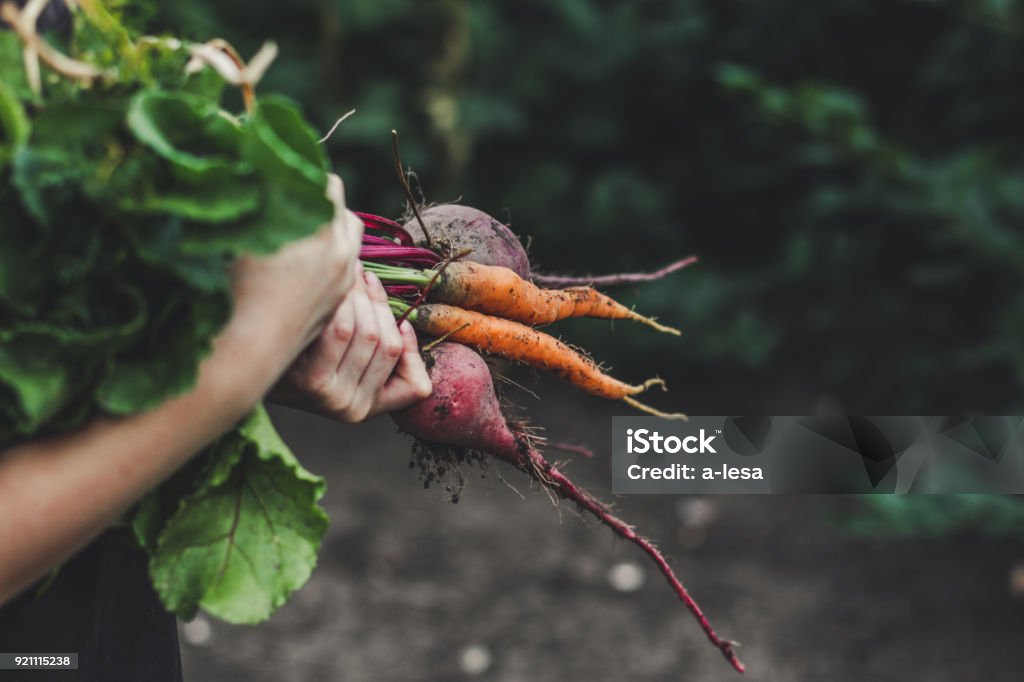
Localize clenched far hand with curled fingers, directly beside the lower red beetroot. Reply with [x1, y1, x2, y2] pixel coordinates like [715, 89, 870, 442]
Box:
[269, 267, 431, 423]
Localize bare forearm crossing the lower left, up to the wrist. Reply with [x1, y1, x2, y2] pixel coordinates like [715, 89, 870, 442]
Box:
[0, 307, 299, 603]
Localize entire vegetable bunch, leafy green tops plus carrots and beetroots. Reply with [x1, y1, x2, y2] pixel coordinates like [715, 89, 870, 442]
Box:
[0, 0, 742, 670]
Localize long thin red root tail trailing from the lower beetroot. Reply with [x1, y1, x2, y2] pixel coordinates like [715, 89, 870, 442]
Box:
[526, 447, 744, 673]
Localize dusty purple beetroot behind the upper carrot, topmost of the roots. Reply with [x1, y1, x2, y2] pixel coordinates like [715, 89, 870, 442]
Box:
[403, 204, 529, 280]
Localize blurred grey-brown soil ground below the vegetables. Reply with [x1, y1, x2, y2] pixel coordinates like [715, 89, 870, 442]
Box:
[182, 387, 1024, 682]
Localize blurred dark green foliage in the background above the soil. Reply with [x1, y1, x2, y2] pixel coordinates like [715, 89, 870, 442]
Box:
[142, 0, 1024, 414]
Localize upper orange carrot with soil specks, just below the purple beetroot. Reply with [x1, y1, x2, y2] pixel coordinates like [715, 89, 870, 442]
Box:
[431, 261, 679, 336]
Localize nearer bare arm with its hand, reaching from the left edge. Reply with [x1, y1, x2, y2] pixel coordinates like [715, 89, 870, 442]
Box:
[0, 177, 368, 604]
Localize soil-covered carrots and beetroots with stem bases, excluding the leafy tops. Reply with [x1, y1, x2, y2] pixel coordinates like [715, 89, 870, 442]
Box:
[359, 197, 743, 672]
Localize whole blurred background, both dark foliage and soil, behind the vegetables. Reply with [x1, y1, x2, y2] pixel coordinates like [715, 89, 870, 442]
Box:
[132, 0, 1024, 681]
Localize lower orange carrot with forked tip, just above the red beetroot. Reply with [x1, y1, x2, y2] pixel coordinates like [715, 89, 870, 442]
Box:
[392, 301, 686, 419]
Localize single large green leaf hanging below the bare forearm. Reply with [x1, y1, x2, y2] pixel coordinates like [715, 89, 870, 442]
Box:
[150, 408, 327, 623]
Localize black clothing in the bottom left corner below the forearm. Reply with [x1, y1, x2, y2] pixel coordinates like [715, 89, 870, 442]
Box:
[0, 528, 181, 682]
